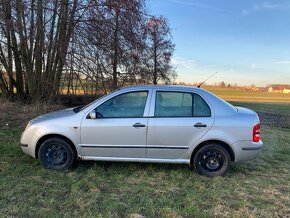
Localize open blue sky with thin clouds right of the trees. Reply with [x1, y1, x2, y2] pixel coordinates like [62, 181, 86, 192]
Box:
[148, 0, 290, 86]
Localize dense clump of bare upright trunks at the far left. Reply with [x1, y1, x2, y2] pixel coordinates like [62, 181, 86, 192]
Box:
[0, 0, 79, 100]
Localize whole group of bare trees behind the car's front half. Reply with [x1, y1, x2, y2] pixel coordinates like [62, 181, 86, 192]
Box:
[0, 0, 176, 101]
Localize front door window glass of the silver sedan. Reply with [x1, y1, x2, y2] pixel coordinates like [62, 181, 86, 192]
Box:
[95, 91, 148, 118]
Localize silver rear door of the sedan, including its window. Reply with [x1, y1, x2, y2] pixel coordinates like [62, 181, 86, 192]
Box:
[146, 91, 214, 159]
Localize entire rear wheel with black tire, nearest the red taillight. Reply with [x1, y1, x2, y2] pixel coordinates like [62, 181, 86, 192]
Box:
[193, 144, 230, 177]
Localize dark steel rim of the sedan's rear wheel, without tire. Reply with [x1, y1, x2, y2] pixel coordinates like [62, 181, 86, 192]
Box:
[199, 151, 224, 171]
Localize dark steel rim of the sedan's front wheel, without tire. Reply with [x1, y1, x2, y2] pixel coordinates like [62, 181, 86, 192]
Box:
[45, 144, 67, 166]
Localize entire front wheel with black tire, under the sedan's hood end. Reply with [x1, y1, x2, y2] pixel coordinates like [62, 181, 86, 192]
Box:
[38, 138, 76, 170]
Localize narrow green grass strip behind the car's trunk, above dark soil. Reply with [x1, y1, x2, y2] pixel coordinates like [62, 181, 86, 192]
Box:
[230, 102, 290, 116]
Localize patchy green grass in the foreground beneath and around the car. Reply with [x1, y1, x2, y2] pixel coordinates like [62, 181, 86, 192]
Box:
[0, 127, 290, 217]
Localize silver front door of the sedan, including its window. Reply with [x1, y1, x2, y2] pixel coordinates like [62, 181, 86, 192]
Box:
[81, 90, 149, 158]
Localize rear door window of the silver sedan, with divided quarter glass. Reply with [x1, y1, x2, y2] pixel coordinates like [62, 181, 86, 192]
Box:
[155, 92, 211, 117]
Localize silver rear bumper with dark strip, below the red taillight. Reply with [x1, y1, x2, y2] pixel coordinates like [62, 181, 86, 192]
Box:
[233, 141, 263, 162]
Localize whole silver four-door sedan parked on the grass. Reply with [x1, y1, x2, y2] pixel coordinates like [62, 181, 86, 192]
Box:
[20, 85, 263, 177]
